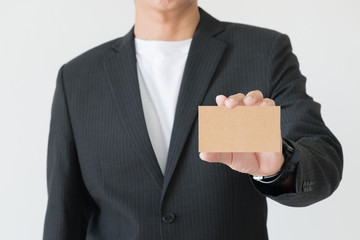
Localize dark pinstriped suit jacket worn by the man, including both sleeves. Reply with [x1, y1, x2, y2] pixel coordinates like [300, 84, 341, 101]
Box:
[44, 8, 342, 240]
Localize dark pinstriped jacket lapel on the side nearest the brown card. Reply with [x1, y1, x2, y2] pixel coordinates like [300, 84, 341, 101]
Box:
[162, 7, 227, 199]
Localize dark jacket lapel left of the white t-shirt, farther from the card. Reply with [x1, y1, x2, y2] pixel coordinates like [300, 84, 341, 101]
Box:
[104, 26, 163, 189]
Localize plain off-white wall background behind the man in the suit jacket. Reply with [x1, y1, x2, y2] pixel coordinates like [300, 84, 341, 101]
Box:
[0, 0, 360, 240]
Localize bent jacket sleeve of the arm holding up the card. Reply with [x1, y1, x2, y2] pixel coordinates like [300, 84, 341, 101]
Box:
[253, 34, 343, 207]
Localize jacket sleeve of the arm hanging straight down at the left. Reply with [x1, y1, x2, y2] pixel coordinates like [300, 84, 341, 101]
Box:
[43, 66, 94, 240]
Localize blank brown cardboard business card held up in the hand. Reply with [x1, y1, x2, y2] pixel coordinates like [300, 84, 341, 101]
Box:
[199, 106, 281, 152]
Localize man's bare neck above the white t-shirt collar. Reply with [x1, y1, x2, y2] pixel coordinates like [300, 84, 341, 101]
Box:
[134, 2, 200, 41]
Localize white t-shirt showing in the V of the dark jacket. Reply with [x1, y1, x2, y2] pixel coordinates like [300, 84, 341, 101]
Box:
[135, 38, 192, 174]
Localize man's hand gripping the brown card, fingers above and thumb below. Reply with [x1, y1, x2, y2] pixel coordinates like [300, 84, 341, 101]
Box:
[200, 90, 284, 176]
